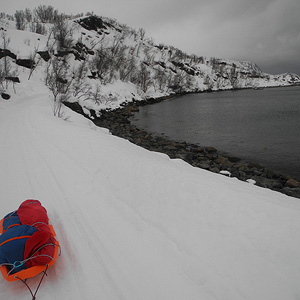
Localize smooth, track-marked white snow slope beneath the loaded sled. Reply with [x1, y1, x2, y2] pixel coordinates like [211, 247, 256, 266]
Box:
[0, 64, 300, 300]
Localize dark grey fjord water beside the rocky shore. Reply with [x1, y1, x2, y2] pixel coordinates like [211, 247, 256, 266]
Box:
[132, 86, 300, 179]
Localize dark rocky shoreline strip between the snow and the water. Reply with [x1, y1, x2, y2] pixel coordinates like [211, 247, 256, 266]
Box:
[65, 97, 300, 198]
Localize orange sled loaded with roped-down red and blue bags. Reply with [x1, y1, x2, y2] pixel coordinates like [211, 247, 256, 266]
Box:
[0, 200, 60, 282]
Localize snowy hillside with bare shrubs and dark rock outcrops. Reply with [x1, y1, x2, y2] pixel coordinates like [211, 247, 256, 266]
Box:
[0, 11, 300, 113]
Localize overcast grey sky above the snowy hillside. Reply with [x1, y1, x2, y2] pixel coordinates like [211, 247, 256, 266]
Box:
[0, 0, 300, 75]
